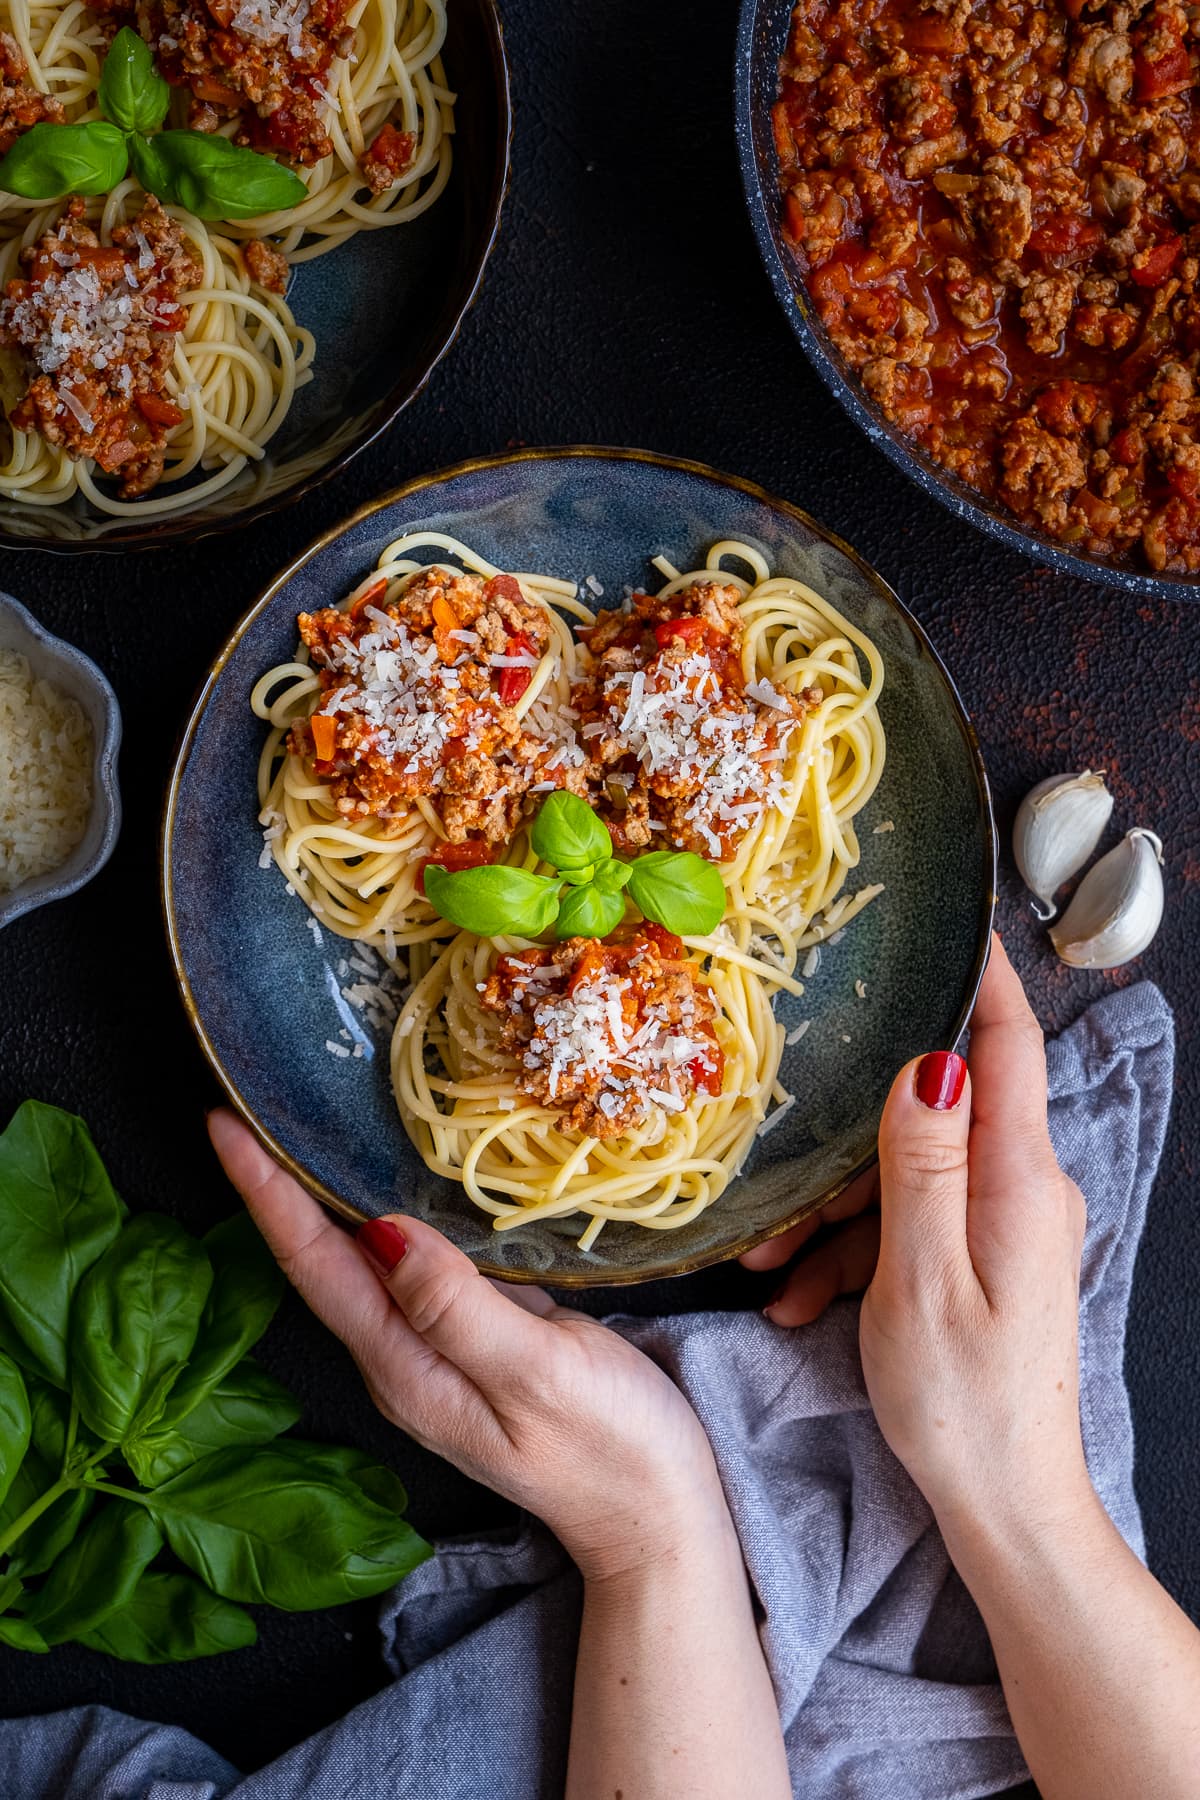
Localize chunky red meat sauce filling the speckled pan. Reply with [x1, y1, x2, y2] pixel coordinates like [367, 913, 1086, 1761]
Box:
[774, 0, 1200, 571]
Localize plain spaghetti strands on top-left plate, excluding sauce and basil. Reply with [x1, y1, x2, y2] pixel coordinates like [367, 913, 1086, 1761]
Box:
[0, 0, 453, 517]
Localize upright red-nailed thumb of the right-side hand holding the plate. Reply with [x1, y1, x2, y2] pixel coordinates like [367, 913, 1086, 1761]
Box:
[880, 1049, 972, 1283]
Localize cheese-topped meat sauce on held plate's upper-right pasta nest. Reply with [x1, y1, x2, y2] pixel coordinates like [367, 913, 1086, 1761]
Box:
[574, 581, 820, 862]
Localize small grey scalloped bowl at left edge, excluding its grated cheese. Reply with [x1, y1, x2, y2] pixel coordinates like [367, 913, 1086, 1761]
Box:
[0, 594, 121, 927]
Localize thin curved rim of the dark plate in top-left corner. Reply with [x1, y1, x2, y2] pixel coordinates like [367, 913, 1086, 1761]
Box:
[0, 0, 513, 556]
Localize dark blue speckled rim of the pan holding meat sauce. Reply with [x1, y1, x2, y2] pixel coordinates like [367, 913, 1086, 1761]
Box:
[734, 0, 1200, 599]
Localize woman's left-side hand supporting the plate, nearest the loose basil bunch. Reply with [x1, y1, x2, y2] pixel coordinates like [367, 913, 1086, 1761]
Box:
[209, 1111, 725, 1579]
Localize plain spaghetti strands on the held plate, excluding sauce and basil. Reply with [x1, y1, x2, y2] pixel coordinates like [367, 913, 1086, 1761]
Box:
[252, 535, 885, 1249]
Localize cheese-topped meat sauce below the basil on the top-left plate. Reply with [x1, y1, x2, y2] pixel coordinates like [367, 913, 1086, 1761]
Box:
[0, 198, 200, 500]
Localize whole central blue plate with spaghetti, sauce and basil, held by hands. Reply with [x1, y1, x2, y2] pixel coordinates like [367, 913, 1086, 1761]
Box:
[164, 450, 995, 1285]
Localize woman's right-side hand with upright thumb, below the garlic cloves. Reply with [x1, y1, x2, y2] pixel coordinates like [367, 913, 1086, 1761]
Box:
[747, 938, 1090, 1535]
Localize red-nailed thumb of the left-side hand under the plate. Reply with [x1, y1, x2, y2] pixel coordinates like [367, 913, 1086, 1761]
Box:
[358, 1215, 554, 1395]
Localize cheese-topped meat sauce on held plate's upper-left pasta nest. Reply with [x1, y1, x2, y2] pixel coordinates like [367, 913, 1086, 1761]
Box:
[291, 569, 585, 842]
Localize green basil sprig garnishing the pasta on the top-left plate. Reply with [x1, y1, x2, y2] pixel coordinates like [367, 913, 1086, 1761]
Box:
[0, 25, 308, 220]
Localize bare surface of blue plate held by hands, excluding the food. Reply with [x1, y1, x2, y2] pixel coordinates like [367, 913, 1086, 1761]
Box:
[162, 450, 995, 1285]
